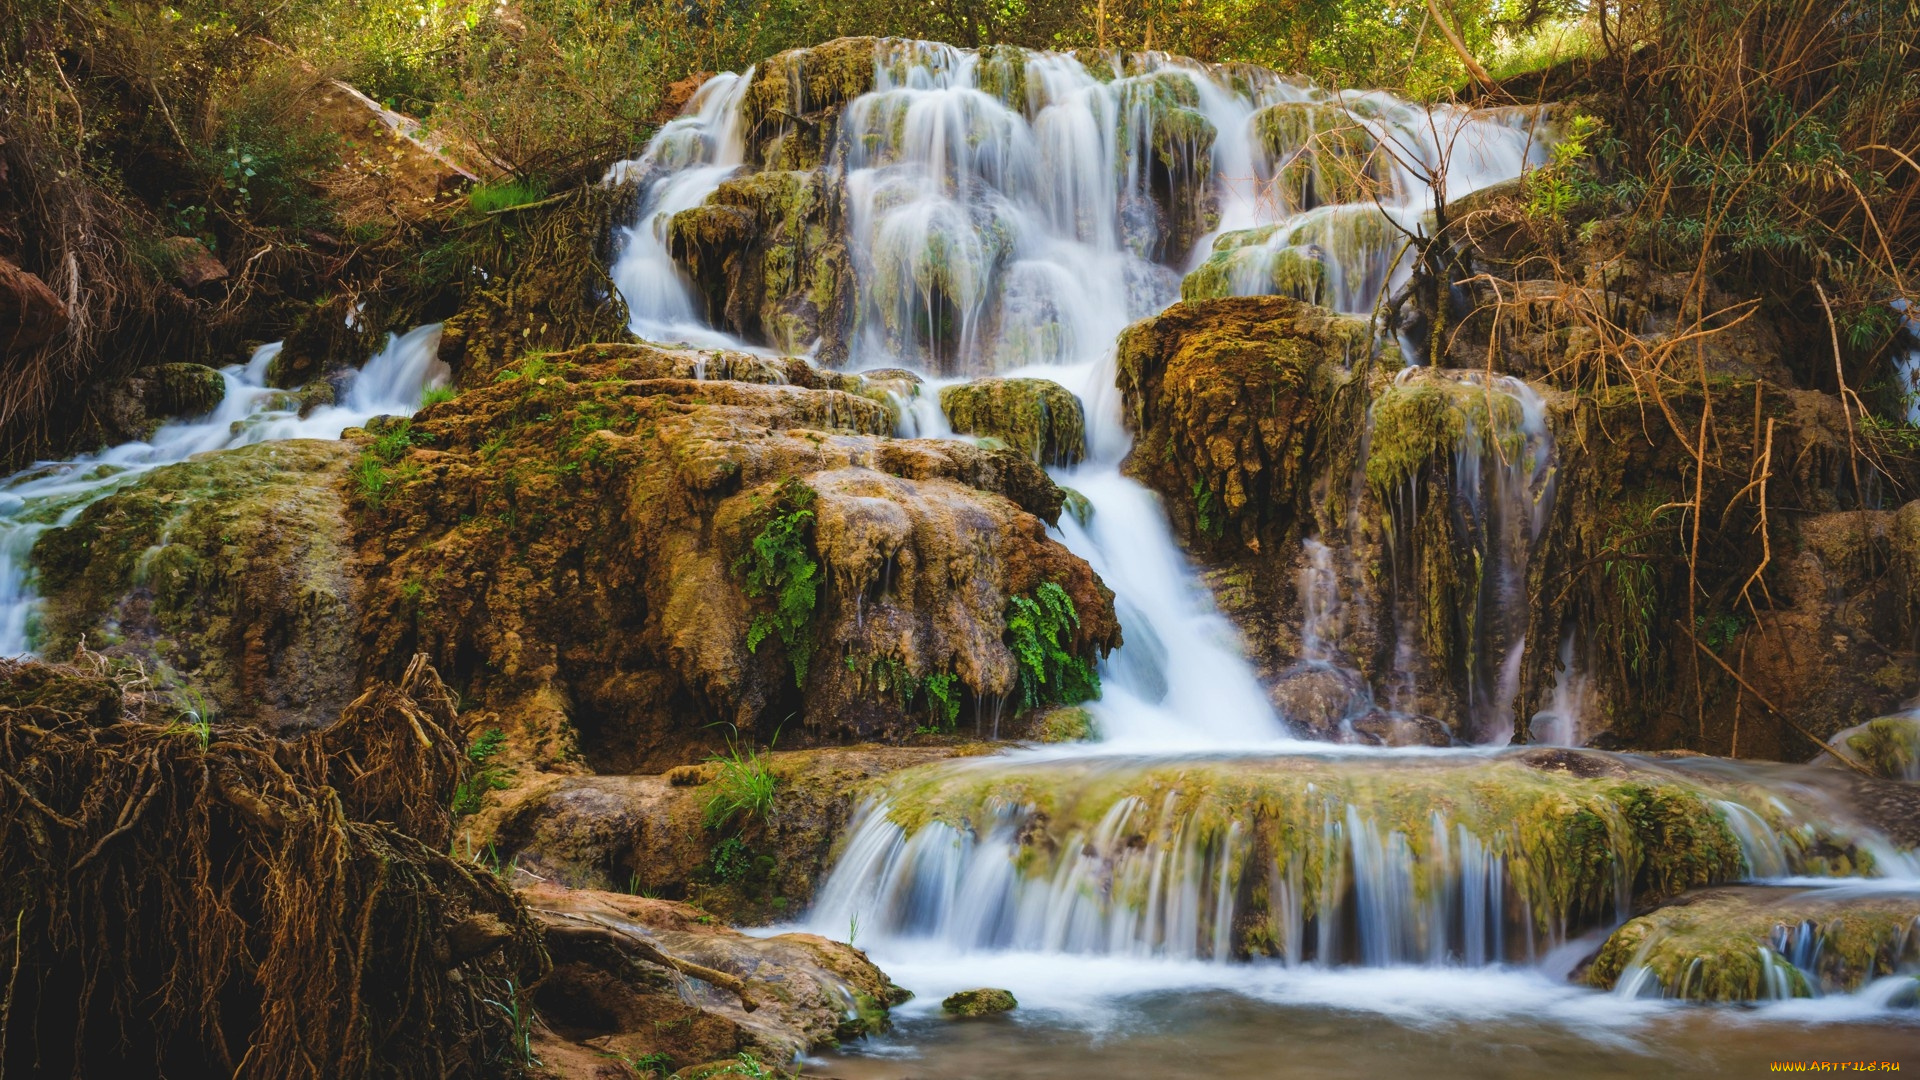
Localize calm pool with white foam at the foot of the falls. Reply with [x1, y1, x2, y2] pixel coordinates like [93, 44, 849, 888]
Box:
[806, 959, 1920, 1080]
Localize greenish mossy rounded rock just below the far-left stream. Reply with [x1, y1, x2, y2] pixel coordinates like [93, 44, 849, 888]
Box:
[33, 440, 362, 726]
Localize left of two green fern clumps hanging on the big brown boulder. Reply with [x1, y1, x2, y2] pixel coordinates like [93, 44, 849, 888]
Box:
[733, 477, 820, 686]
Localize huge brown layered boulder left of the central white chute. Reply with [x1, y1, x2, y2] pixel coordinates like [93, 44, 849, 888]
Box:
[363, 336, 1117, 771]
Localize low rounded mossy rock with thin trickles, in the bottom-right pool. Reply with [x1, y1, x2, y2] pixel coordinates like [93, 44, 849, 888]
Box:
[1586, 886, 1920, 1001]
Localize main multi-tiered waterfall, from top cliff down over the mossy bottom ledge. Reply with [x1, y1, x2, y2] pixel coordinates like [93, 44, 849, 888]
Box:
[609, 40, 1910, 1053]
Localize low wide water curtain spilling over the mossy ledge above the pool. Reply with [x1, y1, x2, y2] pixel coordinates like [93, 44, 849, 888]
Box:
[808, 755, 1908, 968]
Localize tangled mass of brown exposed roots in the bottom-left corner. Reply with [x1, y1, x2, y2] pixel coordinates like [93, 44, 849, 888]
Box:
[0, 641, 547, 1078]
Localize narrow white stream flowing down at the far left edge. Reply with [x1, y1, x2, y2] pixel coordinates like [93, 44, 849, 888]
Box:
[0, 323, 447, 655]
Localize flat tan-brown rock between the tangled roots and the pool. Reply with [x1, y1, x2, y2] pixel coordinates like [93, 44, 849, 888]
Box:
[520, 884, 908, 1065]
